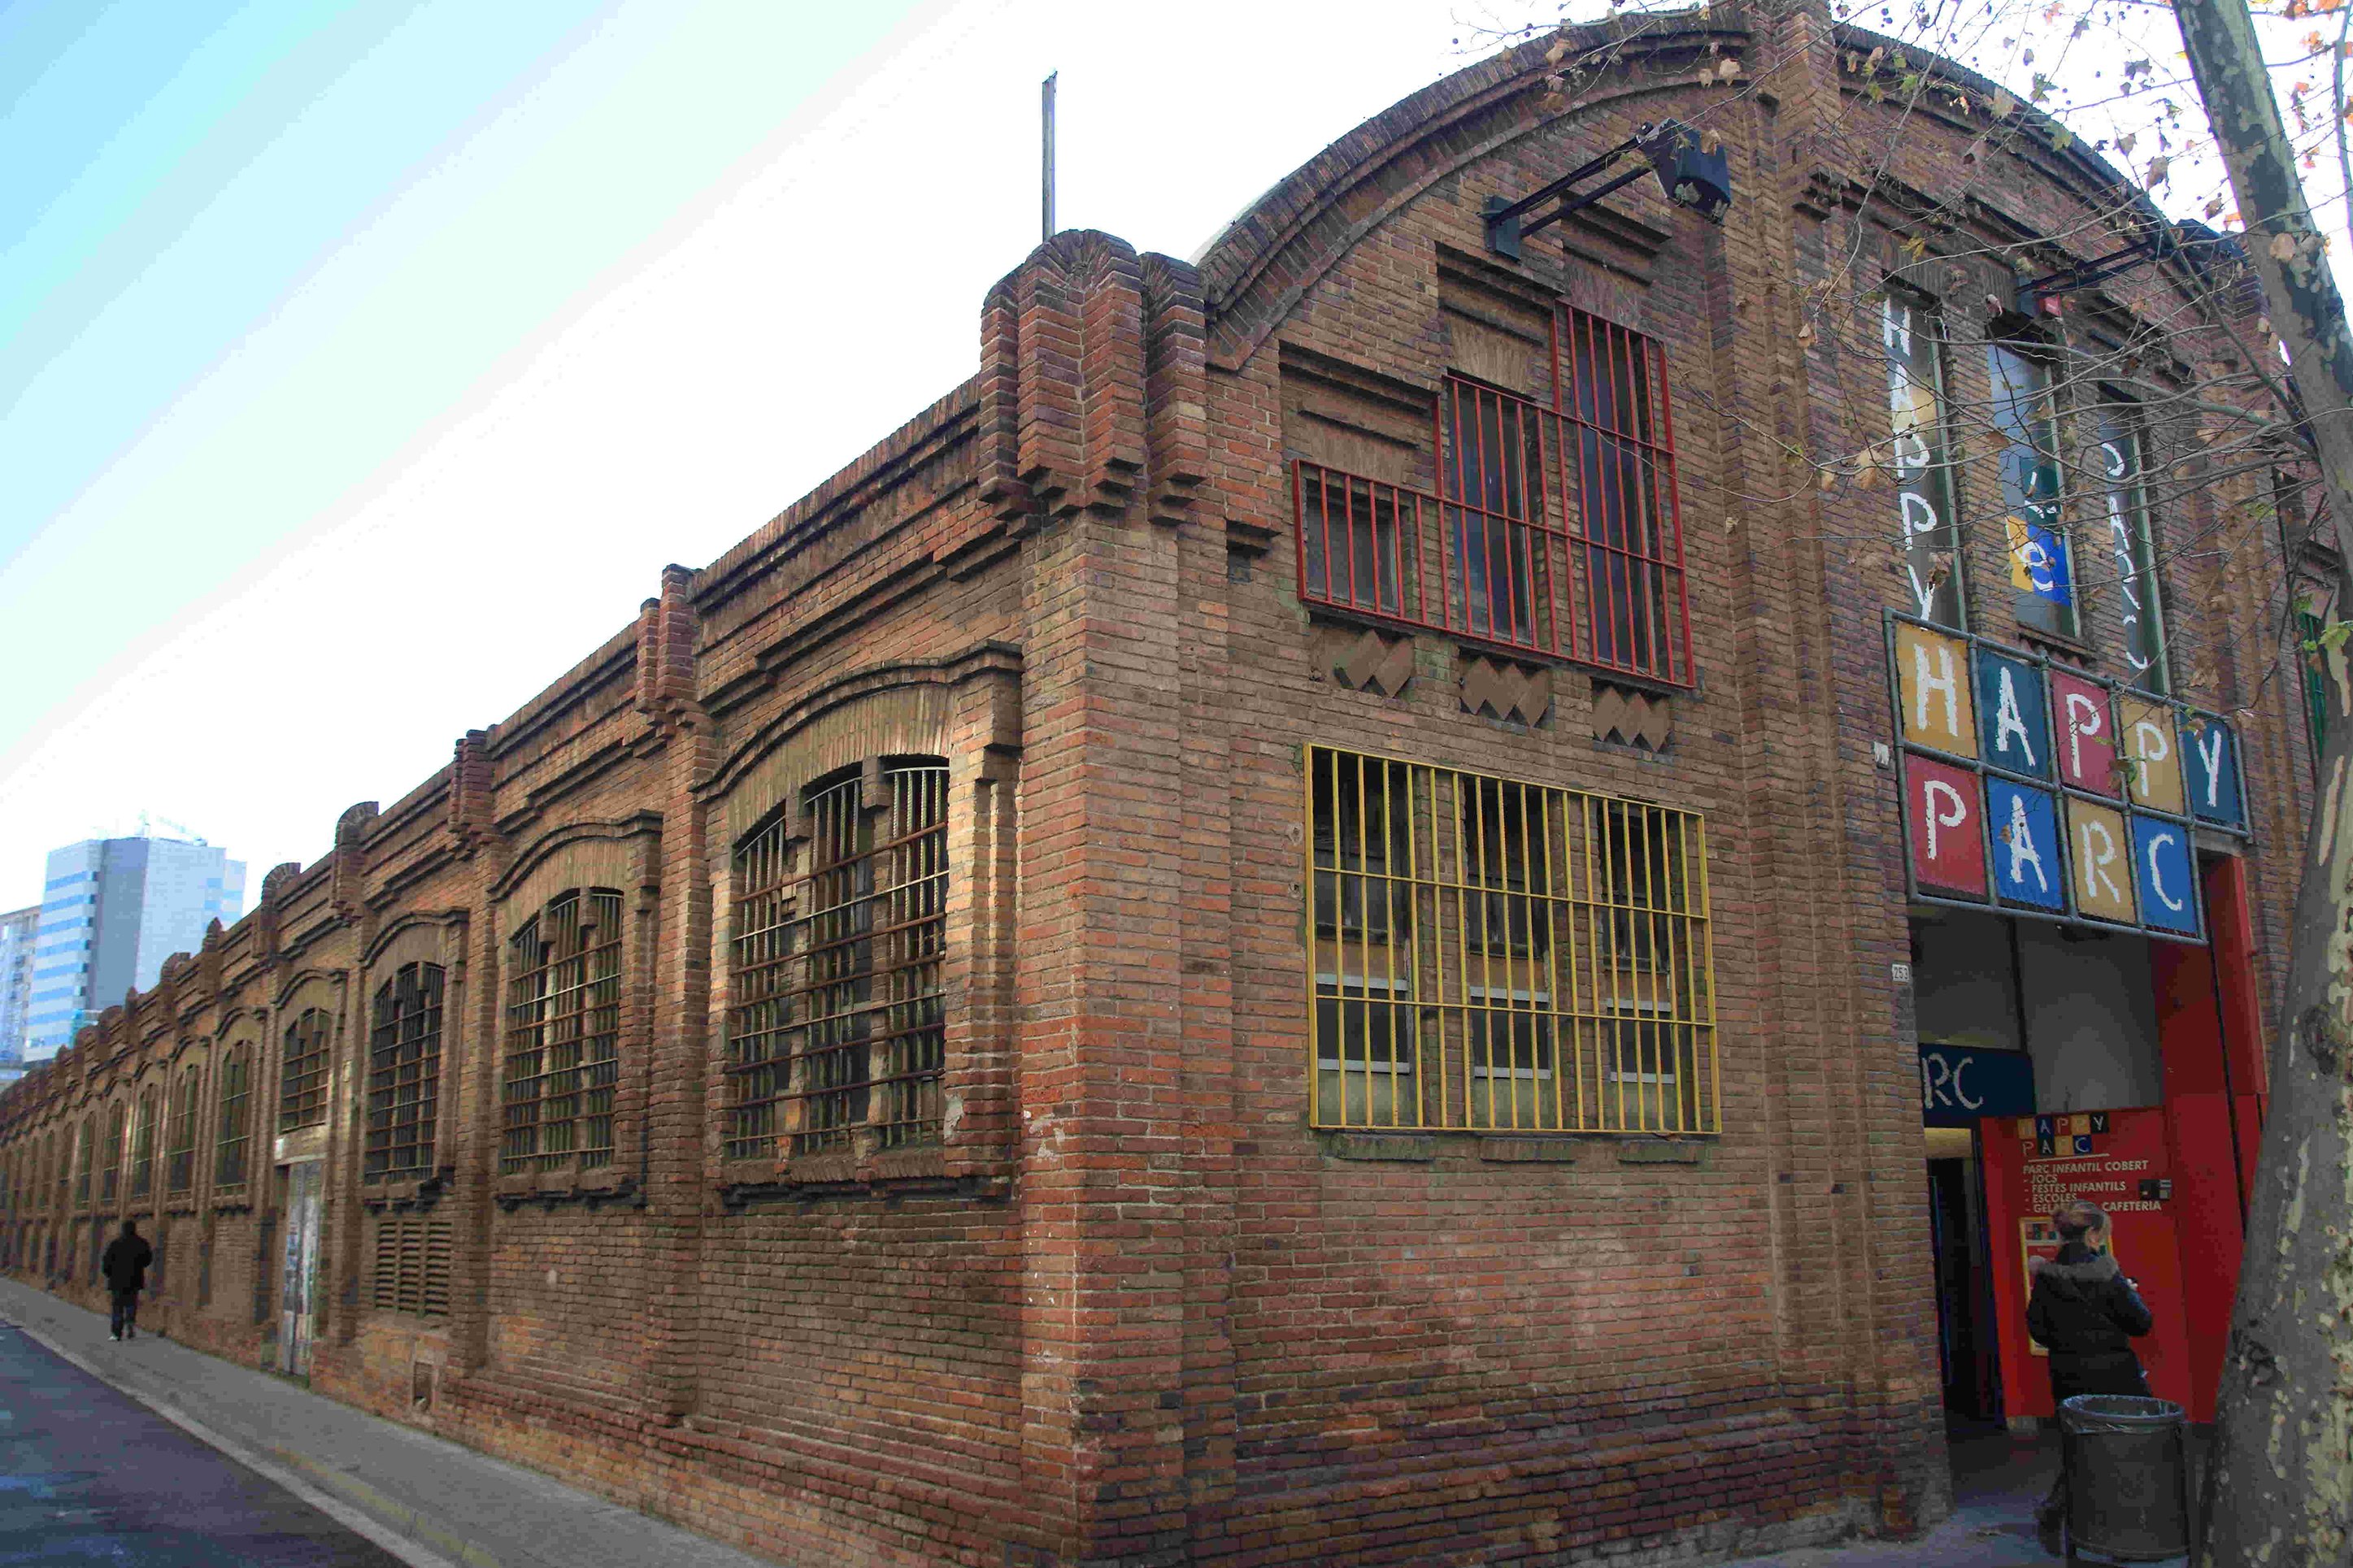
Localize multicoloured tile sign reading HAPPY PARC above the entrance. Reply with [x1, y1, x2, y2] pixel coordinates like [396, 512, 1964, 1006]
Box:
[1887, 616, 2247, 940]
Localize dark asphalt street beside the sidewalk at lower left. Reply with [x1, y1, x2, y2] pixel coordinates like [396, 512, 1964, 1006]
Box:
[0, 1323, 400, 1568]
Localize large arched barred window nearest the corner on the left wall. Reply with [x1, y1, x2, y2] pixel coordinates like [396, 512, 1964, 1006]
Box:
[727, 759, 948, 1159]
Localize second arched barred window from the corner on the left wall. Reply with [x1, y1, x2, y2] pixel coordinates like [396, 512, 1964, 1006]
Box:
[499, 888, 621, 1173]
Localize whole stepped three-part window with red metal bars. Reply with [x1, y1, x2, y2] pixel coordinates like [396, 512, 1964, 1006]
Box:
[1294, 306, 1692, 686]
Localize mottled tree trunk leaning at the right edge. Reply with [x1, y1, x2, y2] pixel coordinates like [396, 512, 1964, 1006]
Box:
[2177, 0, 2353, 1568]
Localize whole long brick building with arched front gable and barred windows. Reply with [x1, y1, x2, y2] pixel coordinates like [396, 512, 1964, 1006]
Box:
[0, 7, 2311, 1566]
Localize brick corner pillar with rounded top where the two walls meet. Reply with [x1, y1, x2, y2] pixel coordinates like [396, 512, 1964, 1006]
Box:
[979, 230, 1231, 1568]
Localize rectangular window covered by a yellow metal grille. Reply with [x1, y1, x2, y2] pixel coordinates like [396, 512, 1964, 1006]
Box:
[1306, 745, 1720, 1133]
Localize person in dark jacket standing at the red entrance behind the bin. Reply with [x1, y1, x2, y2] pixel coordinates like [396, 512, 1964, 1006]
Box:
[2026, 1199, 2155, 1554]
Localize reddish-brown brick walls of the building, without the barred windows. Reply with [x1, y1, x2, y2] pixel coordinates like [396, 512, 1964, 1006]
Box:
[0, 7, 2311, 1568]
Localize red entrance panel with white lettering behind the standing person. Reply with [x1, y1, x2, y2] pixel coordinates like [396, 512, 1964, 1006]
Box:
[1979, 1105, 2212, 1420]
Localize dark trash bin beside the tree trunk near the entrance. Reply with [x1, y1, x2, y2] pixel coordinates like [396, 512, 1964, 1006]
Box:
[2059, 1394, 2190, 1563]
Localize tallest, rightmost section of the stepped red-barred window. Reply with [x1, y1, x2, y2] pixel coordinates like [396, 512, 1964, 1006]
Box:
[1553, 311, 1692, 686]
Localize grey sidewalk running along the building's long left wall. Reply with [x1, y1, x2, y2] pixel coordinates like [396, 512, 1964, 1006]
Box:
[0, 1279, 795, 1568]
